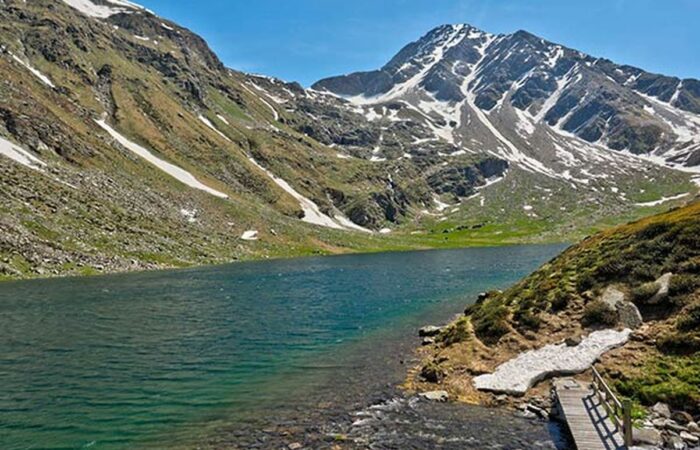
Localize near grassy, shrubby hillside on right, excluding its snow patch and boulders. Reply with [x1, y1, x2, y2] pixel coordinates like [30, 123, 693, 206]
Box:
[410, 202, 700, 413]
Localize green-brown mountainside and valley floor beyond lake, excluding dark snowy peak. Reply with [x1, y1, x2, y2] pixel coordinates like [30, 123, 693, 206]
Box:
[0, 0, 696, 278]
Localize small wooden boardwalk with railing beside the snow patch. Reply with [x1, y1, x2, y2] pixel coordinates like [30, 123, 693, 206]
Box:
[554, 378, 627, 450]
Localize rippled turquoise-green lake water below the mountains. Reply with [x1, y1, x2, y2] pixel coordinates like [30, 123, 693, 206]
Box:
[0, 246, 562, 449]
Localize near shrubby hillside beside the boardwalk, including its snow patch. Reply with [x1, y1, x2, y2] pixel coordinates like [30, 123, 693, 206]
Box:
[408, 202, 700, 448]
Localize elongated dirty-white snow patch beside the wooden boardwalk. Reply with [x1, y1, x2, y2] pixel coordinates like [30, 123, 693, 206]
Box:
[473, 329, 631, 395]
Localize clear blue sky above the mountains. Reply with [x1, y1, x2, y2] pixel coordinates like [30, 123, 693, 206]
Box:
[139, 0, 700, 85]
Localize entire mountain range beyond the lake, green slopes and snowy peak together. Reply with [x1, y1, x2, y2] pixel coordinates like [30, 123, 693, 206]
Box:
[0, 0, 700, 278]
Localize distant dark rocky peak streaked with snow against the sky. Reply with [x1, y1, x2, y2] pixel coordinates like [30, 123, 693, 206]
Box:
[313, 25, 700, 168]
